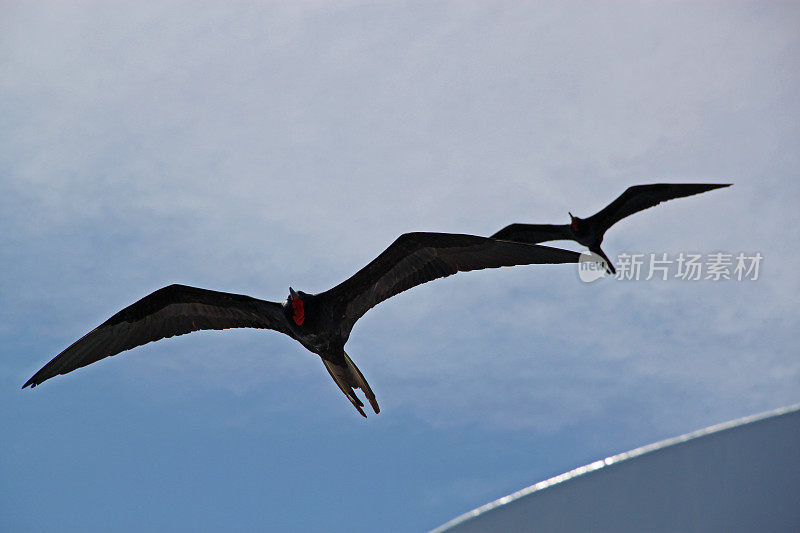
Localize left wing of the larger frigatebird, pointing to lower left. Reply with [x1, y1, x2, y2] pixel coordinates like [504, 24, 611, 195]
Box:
[22, 285, 289, 389]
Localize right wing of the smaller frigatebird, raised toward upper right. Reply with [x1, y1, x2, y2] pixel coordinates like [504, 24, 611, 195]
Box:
[589, 183, 731, 230]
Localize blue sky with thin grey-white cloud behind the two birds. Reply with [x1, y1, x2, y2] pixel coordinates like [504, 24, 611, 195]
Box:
[0, 1, 800, 532]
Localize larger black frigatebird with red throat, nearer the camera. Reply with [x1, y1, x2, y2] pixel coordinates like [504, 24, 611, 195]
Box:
[22, 233, 579, 417]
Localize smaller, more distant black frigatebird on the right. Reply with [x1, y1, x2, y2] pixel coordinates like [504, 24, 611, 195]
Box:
[492, 183, 731, 274]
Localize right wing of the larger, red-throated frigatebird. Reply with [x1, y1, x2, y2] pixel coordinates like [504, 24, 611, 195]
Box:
[318, 233, 579, 337]
